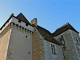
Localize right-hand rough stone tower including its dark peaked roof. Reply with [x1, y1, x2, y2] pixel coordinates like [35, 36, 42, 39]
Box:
[53, 23, 80, 60]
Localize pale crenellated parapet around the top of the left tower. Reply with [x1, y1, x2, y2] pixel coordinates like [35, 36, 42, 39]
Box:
[0, 13, 34, 33]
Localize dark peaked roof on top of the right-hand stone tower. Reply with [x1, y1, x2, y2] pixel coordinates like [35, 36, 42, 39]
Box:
[52, 22, 79, 36]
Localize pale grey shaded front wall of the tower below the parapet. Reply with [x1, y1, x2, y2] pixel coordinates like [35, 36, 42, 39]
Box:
[7, 23, 32, 60]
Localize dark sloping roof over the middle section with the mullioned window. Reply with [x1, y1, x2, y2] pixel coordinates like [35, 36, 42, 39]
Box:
[36, 25, 60, 45]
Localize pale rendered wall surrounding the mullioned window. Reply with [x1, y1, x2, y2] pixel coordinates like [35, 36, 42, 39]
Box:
[44, 40, 63, 60]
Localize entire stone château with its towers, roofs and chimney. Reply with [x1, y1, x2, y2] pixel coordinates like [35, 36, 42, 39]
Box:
[0, 13, 80, 60]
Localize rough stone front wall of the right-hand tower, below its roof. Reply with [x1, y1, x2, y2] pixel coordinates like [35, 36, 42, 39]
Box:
[55, 30, 78, 60]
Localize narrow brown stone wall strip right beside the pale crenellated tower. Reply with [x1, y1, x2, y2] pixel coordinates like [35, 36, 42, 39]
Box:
[32, 28, 45, 60]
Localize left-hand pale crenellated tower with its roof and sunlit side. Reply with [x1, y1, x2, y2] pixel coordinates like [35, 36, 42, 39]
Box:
[0, 13, 34, 60]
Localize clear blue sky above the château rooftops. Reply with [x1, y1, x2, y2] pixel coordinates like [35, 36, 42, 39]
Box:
[0, 0, 80, 32]
